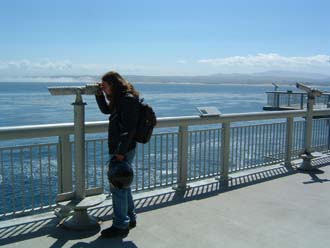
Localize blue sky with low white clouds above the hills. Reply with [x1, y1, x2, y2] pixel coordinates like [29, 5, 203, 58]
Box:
[0, 0, 330, 81]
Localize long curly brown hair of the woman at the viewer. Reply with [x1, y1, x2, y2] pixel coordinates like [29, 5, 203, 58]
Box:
[102, 71, 140, 111]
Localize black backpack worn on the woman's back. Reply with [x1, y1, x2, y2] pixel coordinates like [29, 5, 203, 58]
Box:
[134, 99, 157, 144]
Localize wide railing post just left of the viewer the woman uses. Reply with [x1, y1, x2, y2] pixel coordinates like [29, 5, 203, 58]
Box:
[57, 134, 72, 193]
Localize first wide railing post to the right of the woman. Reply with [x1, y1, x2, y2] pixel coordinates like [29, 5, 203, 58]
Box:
[174, 126, 189, 191]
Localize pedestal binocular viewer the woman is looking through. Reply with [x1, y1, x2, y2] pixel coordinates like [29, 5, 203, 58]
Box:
[48, 85, 106, 230]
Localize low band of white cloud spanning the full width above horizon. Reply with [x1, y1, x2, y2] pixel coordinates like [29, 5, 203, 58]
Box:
[0, 53, 330, 81]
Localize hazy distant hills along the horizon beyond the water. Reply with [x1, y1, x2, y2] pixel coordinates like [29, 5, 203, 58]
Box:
[23, 71, 330, 85]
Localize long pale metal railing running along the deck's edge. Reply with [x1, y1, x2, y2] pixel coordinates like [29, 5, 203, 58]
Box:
[0, 110, 330, 217]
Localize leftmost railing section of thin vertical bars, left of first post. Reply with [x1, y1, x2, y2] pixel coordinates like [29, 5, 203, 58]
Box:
[0, 143, 58, 216]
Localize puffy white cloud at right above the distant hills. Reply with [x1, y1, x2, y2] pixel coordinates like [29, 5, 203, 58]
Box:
[198, 53, 330, 74]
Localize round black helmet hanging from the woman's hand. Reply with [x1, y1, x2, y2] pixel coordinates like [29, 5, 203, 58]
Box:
[108, 158, 134, 189]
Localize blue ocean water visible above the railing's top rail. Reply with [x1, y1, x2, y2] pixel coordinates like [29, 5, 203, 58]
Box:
[0, 83, 273, 127]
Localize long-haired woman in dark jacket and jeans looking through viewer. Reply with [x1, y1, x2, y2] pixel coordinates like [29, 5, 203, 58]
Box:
[96, 71, 139, 238]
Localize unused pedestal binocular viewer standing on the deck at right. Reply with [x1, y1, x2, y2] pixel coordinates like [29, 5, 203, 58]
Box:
[296, 83, 323, 171]
